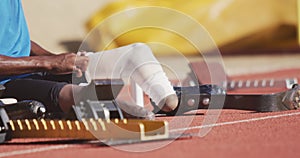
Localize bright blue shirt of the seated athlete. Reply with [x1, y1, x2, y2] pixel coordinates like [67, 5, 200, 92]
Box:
[0, 0, 31, 84]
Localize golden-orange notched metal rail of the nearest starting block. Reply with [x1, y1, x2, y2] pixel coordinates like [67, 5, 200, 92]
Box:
[0, 108, 169, 145]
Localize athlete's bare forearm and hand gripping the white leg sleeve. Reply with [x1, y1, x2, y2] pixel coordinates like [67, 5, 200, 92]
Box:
[0, 42, 88, 77]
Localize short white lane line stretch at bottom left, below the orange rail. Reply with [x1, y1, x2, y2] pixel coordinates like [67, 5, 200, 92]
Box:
[0, 145, 70, 157]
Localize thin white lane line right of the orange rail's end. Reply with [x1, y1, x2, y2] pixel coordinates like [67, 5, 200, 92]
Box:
[170, 112, 300, 132]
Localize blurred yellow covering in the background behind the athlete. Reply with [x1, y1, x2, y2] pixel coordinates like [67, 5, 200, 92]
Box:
[83, 0, 298, 55]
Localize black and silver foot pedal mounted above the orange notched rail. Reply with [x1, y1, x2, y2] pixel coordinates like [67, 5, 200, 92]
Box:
[71, 79, 124, 121]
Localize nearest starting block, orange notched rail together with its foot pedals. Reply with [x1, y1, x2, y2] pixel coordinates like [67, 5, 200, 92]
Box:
[0, 81, 170, 145]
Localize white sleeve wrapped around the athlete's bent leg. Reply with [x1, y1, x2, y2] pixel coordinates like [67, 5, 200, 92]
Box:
[86, 43, 175, 105]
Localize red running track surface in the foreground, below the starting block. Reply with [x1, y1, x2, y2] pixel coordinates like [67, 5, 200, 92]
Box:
[0, 110, 300, 158]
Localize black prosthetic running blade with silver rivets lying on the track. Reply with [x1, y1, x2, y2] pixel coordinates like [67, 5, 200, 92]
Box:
[152, 84, 300, 116]
